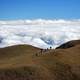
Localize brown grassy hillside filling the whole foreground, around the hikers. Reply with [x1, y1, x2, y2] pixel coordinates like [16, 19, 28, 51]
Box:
[0, 41, 80, 80]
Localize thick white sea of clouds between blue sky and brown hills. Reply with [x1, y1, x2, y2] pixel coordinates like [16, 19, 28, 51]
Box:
[0, 19, 80, 48]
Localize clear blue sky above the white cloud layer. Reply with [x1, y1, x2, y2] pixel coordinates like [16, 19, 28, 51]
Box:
[0, 0, 80, 20]
